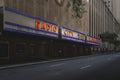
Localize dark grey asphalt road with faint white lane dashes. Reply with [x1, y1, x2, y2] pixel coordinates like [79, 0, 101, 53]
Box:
[0, 53, 120, 80]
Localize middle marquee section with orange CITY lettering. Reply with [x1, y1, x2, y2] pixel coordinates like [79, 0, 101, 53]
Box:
[62, 27, 86, 43]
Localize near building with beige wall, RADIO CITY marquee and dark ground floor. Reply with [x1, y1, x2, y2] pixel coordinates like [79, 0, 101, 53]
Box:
[0, 0, 100, 63]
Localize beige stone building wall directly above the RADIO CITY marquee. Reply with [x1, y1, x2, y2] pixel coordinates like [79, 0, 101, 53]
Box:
[5, 0, 89, 34]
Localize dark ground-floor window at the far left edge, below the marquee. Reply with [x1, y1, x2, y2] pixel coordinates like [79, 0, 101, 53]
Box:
[0, 43, 8, 57]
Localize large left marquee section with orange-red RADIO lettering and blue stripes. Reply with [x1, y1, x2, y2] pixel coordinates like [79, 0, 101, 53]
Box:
[4, 8, 58, 38]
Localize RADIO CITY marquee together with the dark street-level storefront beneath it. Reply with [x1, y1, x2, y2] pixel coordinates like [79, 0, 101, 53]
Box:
[0, 7, 100, 61]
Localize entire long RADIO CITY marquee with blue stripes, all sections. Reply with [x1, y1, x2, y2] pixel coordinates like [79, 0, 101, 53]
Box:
[3, 7, 101, 45]
